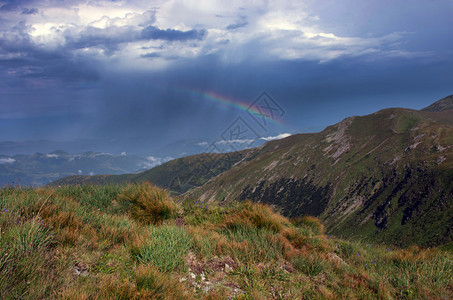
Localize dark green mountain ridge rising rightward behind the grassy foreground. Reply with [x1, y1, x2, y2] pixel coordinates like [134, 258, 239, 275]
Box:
[51, 96, 453, 246]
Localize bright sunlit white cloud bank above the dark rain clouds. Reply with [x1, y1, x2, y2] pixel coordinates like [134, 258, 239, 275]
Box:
[2, 0, 411, 69]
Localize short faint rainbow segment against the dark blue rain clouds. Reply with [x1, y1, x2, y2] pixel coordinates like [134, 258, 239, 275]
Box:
[178, 88, 282, 126]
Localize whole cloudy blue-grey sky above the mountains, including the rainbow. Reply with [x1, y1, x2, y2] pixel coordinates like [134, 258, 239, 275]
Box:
[0, 0, 453, 152]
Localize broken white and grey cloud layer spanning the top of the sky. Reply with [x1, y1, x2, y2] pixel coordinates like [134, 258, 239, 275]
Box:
[0, 1, 444, 75]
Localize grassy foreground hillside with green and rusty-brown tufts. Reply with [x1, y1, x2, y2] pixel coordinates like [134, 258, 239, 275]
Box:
[0, 184, 453, 299]
